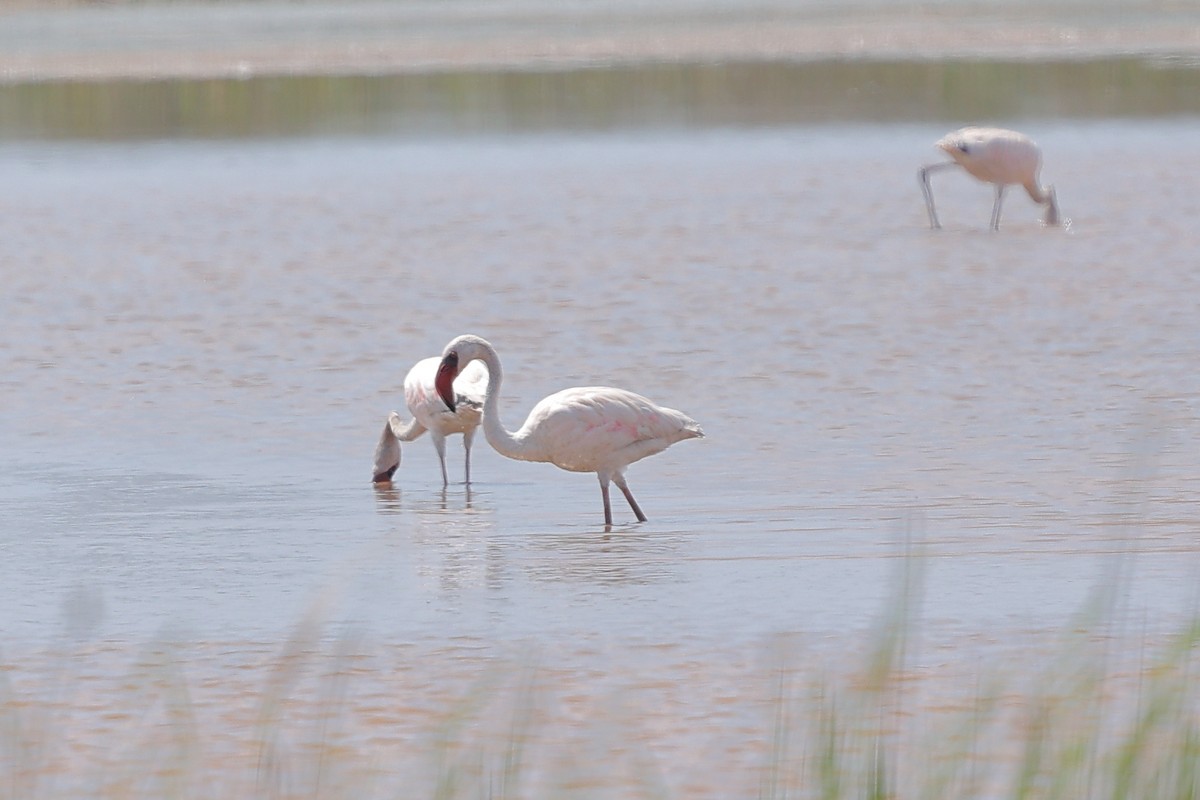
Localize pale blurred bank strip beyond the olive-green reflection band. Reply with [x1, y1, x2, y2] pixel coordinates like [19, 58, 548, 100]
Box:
[7, 0, 1200, 82]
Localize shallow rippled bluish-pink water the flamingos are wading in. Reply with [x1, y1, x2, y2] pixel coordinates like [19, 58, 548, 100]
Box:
[0, 47, 1200, 796]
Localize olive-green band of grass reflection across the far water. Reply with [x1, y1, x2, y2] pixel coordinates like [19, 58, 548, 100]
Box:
[7, 56, 1200, 139]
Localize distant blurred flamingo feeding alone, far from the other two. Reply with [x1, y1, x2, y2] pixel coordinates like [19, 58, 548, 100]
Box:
[917, 128, 1058, 230]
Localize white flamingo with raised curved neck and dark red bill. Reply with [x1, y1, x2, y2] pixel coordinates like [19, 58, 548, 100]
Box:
[434, 335, 704, 528]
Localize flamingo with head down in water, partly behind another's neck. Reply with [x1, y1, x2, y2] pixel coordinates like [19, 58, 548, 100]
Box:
[373, 356, 487, 487]
